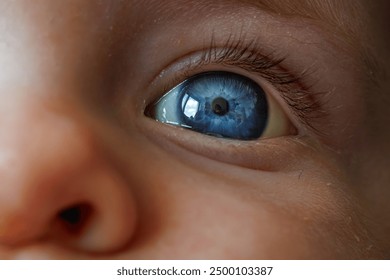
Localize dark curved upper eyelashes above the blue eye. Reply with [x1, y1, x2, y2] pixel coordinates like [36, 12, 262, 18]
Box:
[184, 34, 329, 134]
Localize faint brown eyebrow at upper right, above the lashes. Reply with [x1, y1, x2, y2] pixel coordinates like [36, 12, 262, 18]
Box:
[235, 0, 386, 94]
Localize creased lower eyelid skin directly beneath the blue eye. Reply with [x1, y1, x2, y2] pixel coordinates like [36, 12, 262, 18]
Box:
[140, 118, 304, 172]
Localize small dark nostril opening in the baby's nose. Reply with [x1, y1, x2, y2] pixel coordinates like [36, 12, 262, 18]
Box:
[58, 203, 92, 234]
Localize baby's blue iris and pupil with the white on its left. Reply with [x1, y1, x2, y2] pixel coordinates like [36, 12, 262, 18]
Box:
[151, 72, 268, 140]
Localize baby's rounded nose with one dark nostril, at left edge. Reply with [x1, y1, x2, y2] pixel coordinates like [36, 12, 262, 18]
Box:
[0, 95, 137, 252]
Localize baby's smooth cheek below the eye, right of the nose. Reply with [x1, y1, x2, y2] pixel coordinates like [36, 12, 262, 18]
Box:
[107, 133, 378, 259]
